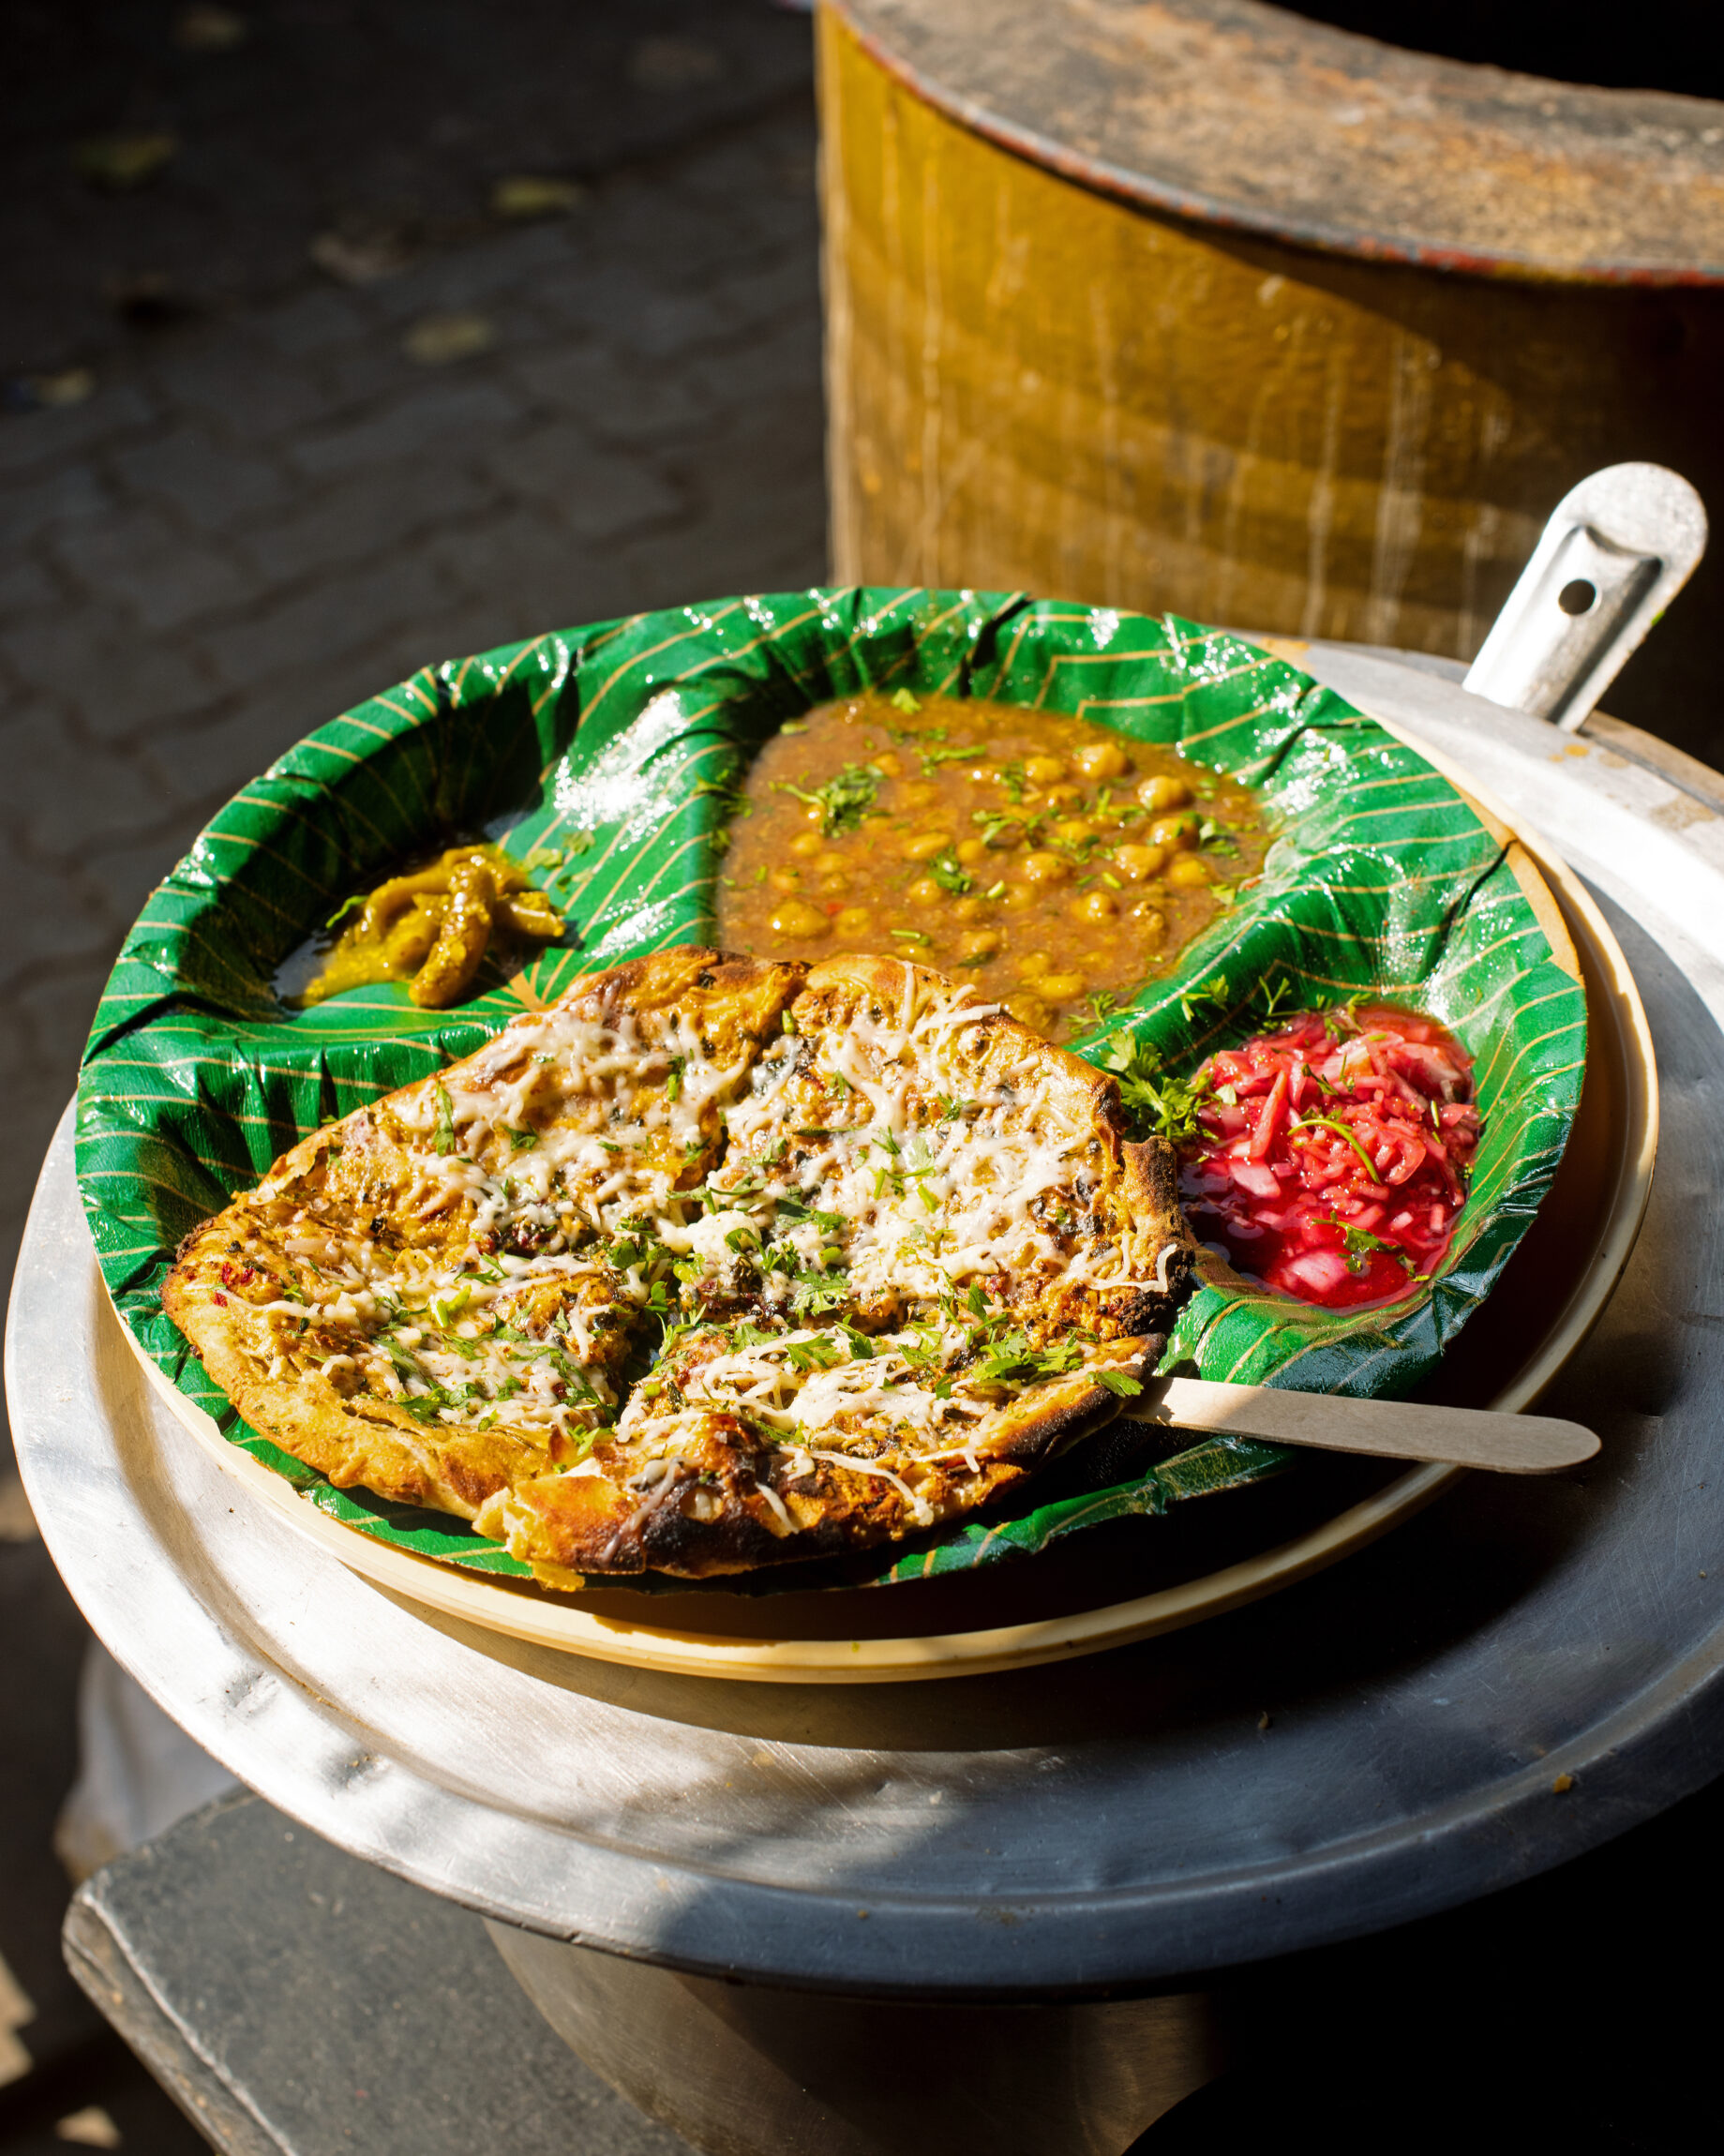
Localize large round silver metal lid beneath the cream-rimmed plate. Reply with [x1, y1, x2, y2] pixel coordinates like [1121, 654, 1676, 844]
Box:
[10, 649, 1724, 1999]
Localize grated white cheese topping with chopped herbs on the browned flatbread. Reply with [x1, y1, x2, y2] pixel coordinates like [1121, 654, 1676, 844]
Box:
[228, 968, 1168, 1473]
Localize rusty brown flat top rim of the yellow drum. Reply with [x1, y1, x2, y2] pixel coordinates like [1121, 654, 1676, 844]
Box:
[825, 0, 1724, 285]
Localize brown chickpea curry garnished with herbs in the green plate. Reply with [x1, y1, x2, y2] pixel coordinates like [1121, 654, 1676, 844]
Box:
[717, 690, 1274, 1040]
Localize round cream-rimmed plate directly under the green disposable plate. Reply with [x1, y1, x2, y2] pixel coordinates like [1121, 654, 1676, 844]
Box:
[116, 758, 1659, 1684]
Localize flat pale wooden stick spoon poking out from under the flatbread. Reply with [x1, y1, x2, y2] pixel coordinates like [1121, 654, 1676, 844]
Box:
[1125, 1378, 1599, 1475]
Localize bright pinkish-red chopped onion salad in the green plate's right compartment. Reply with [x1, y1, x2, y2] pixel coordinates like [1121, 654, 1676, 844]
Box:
[1181, 1005, 1478, 1309]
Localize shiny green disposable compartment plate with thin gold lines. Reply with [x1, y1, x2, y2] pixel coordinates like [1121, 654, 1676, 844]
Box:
[78, 589, 1586, 1594]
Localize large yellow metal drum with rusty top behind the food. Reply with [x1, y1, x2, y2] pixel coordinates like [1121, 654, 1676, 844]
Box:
[821, 0, 1724, 755]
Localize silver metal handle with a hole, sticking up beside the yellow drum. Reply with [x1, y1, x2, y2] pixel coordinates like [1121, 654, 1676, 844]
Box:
[1463, 464, 1707, 733]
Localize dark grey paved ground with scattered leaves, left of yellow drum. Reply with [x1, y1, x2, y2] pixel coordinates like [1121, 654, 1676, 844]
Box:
[0, 0, 825, 2148]
